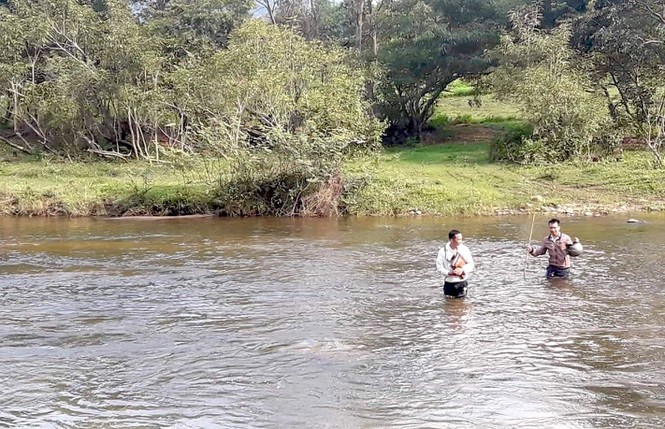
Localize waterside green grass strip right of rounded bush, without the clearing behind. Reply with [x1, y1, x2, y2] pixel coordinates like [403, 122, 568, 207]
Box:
[347, 143, 665, 216]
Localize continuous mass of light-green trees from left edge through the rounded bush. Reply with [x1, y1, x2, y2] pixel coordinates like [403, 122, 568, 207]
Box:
[0, 0, 383, 180]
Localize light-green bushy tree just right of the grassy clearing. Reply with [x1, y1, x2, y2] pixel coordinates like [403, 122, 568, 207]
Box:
[491, 9, 609, 162]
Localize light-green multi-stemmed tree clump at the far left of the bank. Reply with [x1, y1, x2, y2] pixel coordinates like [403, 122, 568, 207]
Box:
[0, 0, 165, 156]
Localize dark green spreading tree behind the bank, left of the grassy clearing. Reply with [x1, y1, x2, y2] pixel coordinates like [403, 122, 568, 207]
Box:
[377, 0, 500, 138]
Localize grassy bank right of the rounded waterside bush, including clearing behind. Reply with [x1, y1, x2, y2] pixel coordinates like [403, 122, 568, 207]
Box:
[342, 92, 665, 215]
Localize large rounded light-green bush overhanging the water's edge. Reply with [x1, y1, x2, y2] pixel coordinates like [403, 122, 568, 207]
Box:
[174, 21, 383, 214]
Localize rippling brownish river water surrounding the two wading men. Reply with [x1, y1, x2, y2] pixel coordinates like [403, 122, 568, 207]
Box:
[0, 215, 665, 429]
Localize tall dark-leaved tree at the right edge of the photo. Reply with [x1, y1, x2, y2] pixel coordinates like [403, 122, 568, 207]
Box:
[574, 0, 665, 167]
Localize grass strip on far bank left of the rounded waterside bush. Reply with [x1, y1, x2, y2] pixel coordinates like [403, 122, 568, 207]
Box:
[0, 160, 222, 216]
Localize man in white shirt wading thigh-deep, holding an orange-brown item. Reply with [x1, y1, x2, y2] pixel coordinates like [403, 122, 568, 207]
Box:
[436, 229, 475, 298]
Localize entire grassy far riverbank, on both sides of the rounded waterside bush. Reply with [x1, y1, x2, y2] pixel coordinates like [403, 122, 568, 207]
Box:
[0, 93, 665, 216]
